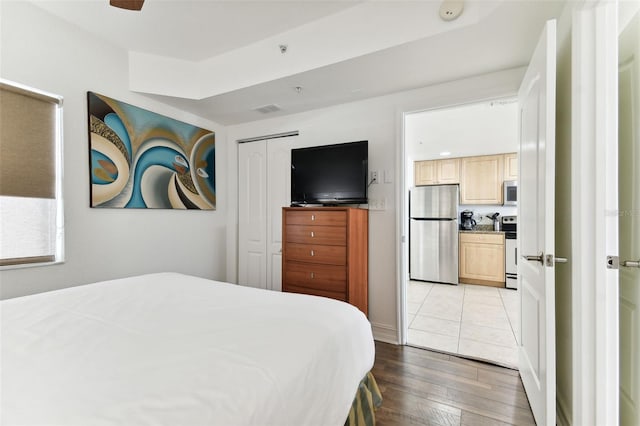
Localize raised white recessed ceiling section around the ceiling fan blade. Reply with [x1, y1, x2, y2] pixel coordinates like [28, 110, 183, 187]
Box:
[33, 0, 359, 61]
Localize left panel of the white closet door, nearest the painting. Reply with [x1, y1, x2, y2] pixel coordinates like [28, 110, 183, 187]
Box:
[238, 141, 267, 288]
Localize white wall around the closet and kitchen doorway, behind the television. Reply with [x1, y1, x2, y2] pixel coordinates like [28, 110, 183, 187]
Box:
[227, 69, 523, 342]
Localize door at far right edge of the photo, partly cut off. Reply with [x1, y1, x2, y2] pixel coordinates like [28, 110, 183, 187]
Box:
[618, 8, 640, 426]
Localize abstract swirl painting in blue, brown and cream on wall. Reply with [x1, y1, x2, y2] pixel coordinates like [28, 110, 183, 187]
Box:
[87, 92, 216, 210]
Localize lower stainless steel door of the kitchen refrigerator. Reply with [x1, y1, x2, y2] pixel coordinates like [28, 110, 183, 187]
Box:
[409, 219, 458, 284]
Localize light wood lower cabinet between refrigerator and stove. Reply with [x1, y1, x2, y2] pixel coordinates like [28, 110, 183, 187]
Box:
[459, 232, 505, 287]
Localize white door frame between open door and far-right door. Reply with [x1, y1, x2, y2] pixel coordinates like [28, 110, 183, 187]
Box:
[571, 0, 619, 424]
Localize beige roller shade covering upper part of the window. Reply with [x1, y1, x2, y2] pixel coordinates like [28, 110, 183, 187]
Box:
[0, 83, 61, 198]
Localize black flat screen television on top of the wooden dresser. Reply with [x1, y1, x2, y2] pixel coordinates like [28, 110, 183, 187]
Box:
[291, 141, 369, 206]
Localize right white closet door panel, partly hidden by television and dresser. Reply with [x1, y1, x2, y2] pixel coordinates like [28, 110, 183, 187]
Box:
[266, 137, 296, 291]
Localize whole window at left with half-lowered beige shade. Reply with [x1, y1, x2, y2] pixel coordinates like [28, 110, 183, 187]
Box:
[0, 79, 63, 267]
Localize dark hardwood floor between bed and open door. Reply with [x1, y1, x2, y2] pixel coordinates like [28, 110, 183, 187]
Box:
[373, 342, 535, 426]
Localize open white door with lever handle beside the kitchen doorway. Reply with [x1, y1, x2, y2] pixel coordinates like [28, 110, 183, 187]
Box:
[518, 20, 556, 426]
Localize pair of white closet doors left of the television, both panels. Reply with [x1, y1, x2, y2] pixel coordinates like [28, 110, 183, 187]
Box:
[238, 137, 296, 291]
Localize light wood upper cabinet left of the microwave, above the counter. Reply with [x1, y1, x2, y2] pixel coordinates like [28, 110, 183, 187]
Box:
[460, 154, 505, 205]
